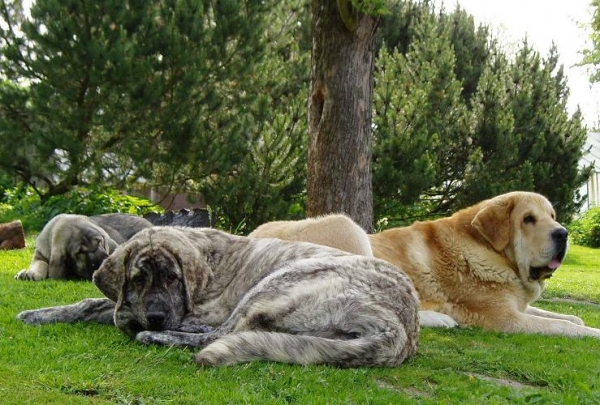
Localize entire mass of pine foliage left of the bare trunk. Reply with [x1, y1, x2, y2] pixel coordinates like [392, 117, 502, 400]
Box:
[0, 0, 310, 228]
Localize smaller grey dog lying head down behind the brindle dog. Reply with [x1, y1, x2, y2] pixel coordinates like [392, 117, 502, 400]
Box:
[15, 214, 152, 281]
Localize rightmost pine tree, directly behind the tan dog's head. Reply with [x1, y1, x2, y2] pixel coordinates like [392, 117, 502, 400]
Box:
[455, 42, 590, 221]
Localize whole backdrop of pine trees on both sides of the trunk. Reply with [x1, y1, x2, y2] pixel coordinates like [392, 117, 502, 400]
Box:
[0, 0, 600, 227]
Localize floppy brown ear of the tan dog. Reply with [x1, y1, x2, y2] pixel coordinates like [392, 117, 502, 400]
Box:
[471, 198, 513, 252]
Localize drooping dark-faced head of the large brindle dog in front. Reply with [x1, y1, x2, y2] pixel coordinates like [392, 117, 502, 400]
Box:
[94, 227, 212, 336]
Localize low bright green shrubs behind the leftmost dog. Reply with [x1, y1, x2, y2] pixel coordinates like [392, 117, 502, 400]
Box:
[0, 188, 162, 232]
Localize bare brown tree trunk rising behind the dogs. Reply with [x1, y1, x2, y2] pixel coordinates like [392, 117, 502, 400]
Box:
[307, 0, 376, 232]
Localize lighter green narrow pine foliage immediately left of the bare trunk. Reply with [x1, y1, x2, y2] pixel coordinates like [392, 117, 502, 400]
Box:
[197, 0, 311, 233]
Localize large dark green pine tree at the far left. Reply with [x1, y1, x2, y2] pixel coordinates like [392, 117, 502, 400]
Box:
[0, 0, 268, 198]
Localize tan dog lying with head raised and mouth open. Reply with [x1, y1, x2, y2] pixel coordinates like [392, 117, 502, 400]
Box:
[250, 192, 600, 338]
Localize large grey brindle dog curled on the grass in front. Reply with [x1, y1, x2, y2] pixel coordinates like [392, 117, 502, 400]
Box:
[18, 227, 419, 367]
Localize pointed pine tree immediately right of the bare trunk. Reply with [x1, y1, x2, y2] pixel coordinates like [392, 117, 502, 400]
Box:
[373, 11, 471, 221]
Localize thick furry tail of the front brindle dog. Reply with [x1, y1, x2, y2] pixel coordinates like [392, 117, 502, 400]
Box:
[196, 329, 417, 367]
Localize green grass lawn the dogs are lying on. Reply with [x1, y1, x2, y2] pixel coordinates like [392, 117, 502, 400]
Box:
[0, 239, 600, 404]
